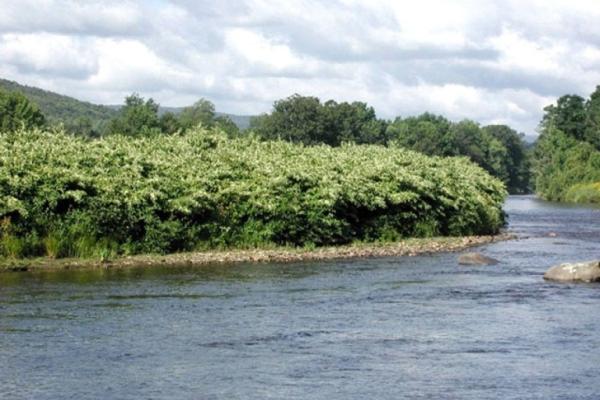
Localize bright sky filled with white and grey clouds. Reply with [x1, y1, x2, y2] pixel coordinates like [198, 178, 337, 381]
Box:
[0, 0, 600, 135]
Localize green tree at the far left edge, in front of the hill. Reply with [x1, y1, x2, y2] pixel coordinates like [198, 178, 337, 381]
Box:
[0, 90, 46, 132]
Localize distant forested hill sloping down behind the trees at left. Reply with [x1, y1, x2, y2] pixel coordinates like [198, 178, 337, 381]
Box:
[0, 78, 251, 129]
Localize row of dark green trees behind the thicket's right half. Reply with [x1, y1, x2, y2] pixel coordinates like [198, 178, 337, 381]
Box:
[250, 95, 530, 193]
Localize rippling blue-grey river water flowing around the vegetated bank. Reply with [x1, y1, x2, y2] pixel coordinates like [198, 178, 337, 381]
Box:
[0, 196, 600, 400]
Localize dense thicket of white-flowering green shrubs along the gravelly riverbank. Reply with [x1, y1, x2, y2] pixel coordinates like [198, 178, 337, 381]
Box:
[0, 128, 505, 257]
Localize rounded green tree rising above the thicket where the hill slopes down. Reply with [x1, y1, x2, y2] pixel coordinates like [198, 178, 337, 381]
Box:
[109, 93, 161, 136]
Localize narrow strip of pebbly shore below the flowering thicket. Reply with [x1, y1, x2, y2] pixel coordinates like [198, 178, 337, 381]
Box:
[0, 233, 516, 272]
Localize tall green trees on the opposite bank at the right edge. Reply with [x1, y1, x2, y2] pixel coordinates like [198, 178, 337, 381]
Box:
[535, 86, 600, 202]
